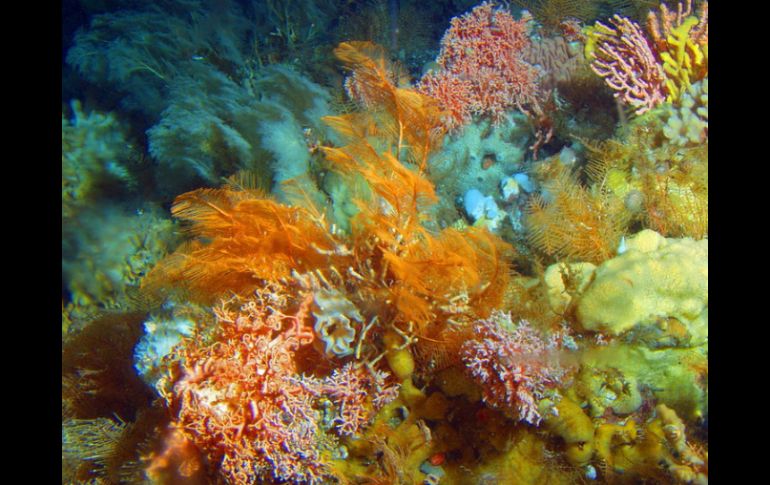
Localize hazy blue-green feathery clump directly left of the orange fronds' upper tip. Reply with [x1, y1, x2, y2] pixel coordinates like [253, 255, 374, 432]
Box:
[147, 65, 330, 197]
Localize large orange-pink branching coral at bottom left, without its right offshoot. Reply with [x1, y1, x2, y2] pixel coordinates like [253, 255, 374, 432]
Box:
[163, 294, 328, 483]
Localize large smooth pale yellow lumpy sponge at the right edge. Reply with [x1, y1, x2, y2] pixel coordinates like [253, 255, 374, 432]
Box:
[577, 230, 708, 337]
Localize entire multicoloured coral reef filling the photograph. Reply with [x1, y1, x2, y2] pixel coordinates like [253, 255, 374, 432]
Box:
[62, 0, 709, 485]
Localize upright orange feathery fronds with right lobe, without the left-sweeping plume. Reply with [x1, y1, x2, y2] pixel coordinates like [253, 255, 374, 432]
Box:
[323, 43, 512, 336]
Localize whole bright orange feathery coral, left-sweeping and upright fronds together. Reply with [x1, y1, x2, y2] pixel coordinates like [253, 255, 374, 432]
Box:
[145, 40, 512, 378]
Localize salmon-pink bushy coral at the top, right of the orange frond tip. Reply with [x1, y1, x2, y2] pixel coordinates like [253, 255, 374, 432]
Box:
[418, 2, 537, 129]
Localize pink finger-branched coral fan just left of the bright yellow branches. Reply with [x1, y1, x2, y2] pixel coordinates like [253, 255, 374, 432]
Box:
[591, 15, 666, 114]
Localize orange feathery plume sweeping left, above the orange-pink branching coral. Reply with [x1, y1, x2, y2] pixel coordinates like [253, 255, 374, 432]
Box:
[144, 188, 350, 301]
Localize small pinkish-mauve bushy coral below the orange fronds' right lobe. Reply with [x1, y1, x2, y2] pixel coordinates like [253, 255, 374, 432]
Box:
[460, 311, 574, 425]
